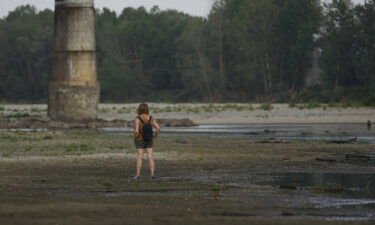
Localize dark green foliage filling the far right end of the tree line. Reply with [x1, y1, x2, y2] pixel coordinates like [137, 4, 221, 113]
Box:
[320, 0, 375, 101]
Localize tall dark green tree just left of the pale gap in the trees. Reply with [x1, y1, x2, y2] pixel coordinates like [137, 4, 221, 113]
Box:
[275, 0, 322, 90]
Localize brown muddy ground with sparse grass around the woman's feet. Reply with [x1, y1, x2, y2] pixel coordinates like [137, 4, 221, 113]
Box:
[0, 130, 375, 225]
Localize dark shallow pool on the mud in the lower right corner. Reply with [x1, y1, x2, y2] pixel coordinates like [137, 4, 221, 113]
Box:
[235, 172, 375, 221]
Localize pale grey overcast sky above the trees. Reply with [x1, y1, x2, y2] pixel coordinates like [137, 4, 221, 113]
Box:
[0, 0, 363, 17]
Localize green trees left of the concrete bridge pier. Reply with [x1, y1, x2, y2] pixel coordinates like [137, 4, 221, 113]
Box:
[0, 5, 53, 100]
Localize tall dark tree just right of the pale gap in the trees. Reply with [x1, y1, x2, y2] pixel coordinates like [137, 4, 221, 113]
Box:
[320, 0, 359, 88]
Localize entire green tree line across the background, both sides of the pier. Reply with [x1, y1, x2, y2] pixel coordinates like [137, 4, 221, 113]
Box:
[0, 0, 375, 102]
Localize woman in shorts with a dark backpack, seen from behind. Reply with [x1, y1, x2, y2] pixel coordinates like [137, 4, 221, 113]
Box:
[133, 103, 160, 179]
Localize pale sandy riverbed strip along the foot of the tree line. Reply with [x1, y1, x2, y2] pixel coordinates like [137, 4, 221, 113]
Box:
[1, 103, 375, 124]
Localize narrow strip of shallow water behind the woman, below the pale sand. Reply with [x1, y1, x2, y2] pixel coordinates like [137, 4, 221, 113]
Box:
[102, 124, 375, 143]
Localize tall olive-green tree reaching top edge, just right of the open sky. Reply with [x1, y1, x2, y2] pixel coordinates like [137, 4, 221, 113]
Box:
[226, 0, 279, 95]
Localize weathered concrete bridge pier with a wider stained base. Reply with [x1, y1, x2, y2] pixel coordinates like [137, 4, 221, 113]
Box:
[48, 0, 100, 121]
